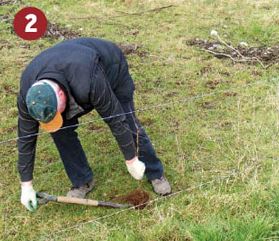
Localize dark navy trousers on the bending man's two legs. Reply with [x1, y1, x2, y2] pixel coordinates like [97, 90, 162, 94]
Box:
[51, 101, 163, 187]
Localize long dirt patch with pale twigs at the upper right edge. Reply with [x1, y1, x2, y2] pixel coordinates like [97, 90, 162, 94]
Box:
[186, 38, 279, 65]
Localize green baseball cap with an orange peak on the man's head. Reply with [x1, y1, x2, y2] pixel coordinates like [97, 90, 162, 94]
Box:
[26, 80, 63, 132]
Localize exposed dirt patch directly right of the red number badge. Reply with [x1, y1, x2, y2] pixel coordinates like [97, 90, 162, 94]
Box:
[45, 22, 80, 39]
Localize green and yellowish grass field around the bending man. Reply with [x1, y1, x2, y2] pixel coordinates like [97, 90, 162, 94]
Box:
[0, 0, 279, 241]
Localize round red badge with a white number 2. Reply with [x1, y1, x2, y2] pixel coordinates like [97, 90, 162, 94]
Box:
[14, 7, 47, 40]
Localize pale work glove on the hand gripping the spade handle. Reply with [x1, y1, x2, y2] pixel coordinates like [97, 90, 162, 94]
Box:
[20, 182, 38, 212]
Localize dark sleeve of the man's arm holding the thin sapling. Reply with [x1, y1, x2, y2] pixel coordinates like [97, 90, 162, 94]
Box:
[90, 64, 136, 160]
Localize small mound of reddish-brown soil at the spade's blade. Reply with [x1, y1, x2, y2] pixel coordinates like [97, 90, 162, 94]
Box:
[114, 188, 149, 209]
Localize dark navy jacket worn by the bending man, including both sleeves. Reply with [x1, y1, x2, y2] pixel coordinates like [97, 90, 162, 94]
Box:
[18, 38, 136, 181]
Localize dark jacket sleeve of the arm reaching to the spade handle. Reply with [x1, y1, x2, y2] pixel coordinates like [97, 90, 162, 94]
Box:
[17, 94, 39, 182]
